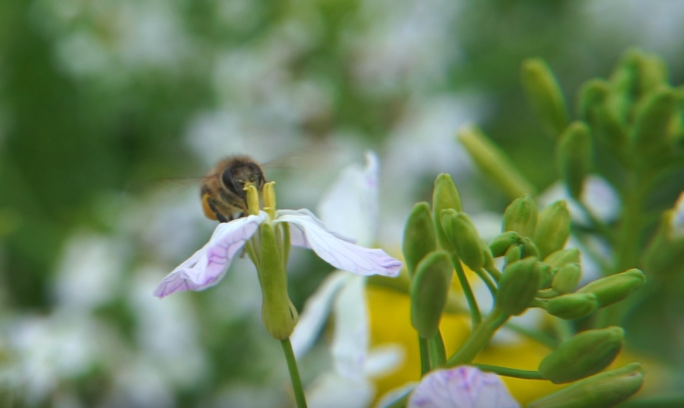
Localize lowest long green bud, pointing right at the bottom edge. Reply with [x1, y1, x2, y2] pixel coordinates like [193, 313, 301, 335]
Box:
[527, 363, 644, 408]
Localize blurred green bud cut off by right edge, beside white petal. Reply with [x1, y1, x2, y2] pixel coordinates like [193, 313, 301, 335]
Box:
[644, 210, 684, 278]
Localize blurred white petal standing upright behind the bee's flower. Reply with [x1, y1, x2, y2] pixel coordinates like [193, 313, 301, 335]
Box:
[318, 151, 380, 246]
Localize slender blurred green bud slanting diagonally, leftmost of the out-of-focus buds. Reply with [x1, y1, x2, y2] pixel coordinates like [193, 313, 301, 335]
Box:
[458, 126, 536, 198]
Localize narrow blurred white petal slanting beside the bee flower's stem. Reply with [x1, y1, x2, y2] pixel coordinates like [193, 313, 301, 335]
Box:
[290, 271, 353, 358]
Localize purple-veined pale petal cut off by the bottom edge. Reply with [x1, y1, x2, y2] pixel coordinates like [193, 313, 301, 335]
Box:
[408, 366, 520, 408]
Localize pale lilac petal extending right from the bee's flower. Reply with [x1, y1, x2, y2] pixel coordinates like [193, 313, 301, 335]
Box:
[274, 209, 402, 277]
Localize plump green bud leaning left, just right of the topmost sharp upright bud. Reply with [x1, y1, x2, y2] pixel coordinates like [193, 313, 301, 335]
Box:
[441, 210, 485, 271]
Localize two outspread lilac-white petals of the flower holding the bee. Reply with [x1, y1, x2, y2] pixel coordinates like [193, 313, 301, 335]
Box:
[154, 189, 402, 298]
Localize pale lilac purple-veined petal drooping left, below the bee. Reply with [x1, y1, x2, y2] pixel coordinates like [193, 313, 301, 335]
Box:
[154, 212, 268, 298]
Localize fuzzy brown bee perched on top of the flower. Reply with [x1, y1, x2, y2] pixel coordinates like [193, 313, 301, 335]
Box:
[200, 156, 266, 222]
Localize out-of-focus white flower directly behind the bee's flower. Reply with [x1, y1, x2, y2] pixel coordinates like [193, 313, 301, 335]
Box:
[290, 152, 402, 408]
